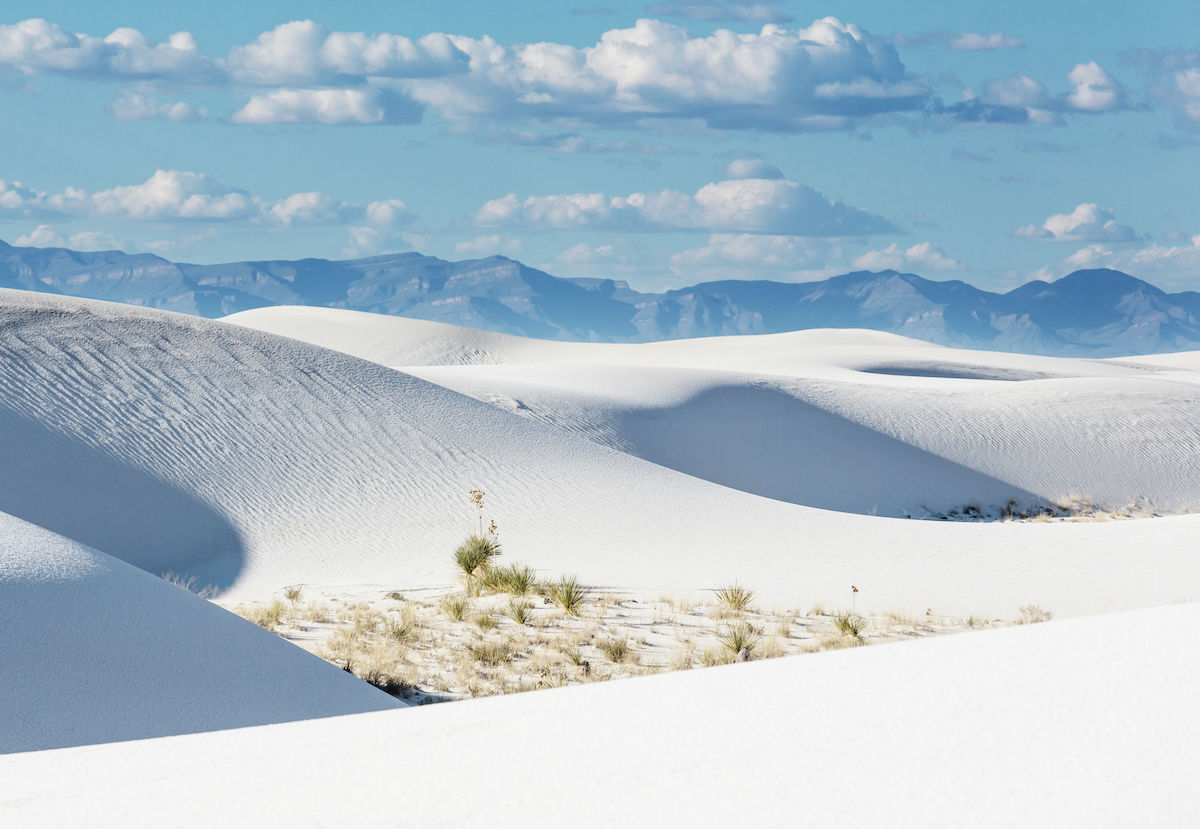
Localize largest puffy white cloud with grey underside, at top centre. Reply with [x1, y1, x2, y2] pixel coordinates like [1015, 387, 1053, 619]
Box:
[406, 18, 928, 130]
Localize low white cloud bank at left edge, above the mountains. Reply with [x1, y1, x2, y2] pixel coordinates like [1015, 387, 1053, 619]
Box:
[0, 170, 410, 228]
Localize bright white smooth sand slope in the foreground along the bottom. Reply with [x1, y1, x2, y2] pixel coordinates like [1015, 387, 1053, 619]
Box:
[0, 605, 1200, 827]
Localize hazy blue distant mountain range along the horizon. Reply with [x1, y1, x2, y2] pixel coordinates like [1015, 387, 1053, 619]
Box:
[0, 241, 1200, 356]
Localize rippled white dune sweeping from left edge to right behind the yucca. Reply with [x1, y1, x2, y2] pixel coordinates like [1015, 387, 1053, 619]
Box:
[0, 292, 1200, 618]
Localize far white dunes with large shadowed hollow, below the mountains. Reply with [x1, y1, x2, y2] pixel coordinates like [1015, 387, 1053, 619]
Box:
[229, 308, 1200, 516]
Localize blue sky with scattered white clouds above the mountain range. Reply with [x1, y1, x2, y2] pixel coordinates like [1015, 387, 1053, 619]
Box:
[0, 0, 1200, 290]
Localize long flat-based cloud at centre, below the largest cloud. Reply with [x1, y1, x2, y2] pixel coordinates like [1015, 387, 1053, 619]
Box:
[473, 179, 895, 236]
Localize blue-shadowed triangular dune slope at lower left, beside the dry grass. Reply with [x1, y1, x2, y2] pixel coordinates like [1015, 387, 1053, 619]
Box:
[0, 513, 397, 753]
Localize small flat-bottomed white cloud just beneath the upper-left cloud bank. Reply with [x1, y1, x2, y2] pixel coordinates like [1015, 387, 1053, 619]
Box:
[230, 88, 421, 125]
